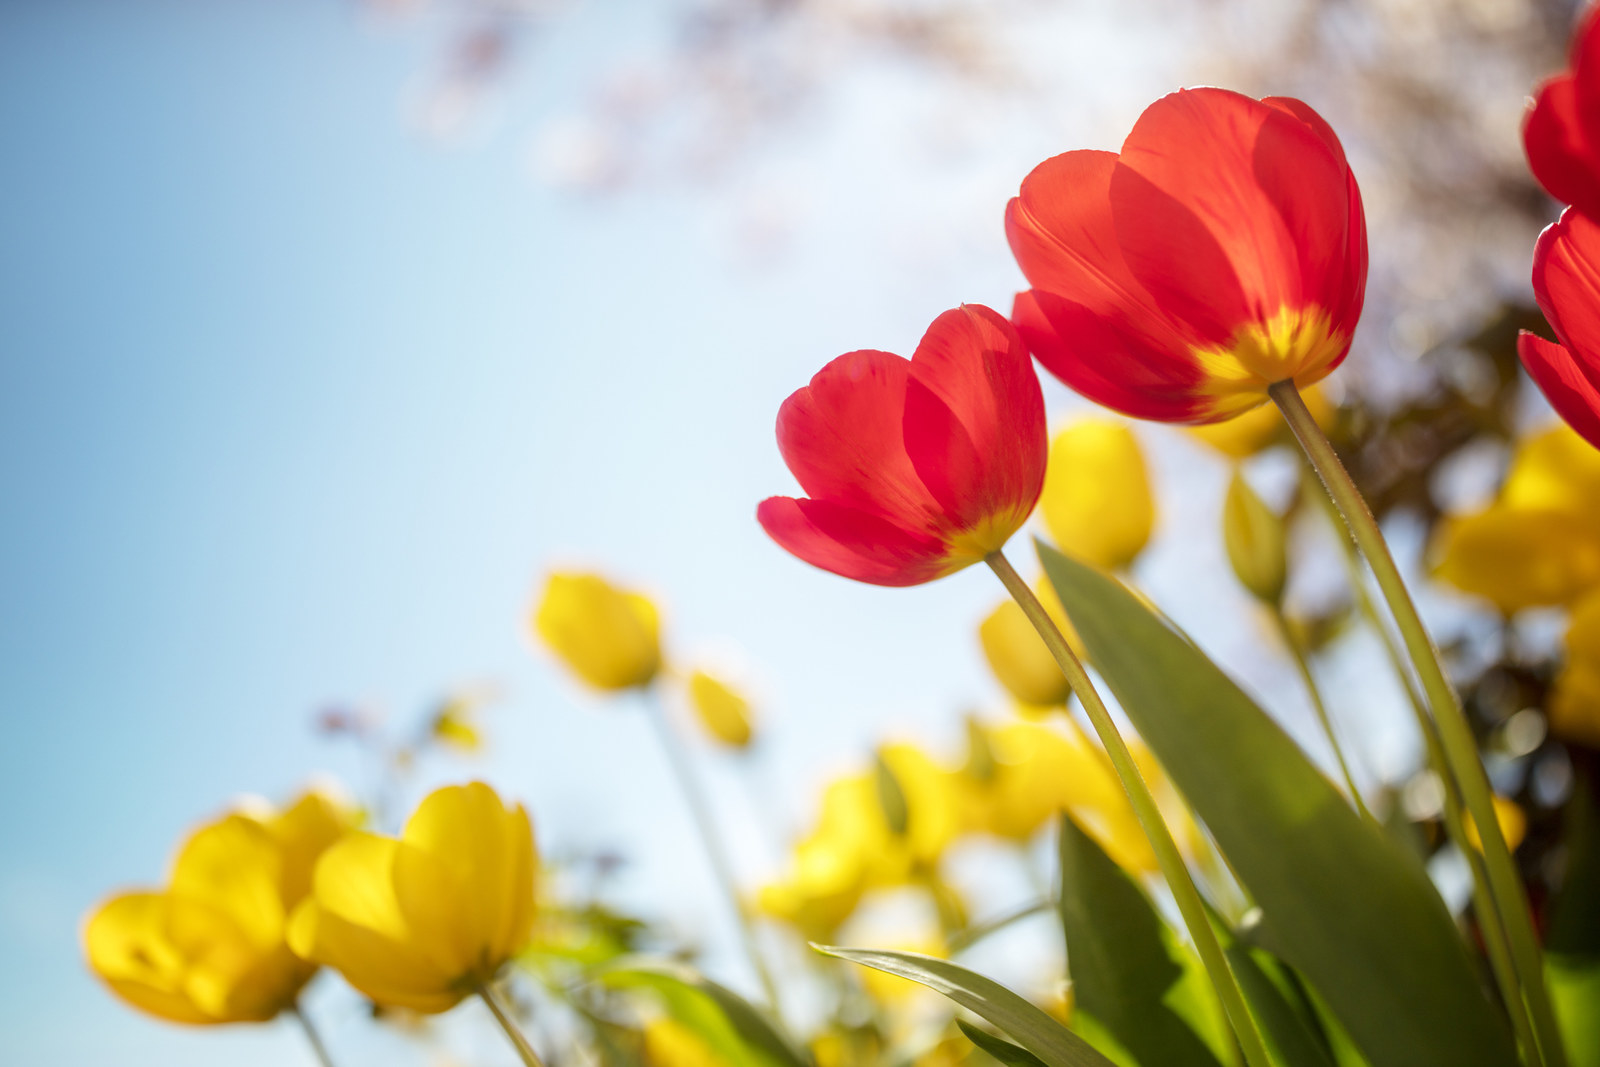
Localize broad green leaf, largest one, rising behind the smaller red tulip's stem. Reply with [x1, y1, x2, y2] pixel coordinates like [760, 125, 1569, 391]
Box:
[1038, 544, 1517, 1067]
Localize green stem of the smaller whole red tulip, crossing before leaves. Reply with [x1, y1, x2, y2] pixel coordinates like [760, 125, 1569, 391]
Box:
[984, 552, 1272, 1067]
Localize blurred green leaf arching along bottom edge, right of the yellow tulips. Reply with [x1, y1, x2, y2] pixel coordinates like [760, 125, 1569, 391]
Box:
[595, 957, 811, 1067]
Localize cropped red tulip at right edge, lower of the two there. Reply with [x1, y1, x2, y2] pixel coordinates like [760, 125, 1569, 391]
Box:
[1517, 208, 1600, 448]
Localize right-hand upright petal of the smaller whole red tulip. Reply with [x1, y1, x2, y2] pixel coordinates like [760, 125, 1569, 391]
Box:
[906, 304, 1048, 528]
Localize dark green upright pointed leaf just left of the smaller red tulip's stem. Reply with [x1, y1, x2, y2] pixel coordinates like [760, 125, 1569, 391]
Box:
[1058, 814, 1219, 1067]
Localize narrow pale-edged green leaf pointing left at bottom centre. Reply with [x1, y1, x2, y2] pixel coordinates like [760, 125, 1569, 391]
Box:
[811, 945, 1115, 1067]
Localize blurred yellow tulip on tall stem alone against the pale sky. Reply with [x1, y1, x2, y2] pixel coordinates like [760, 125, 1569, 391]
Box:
[534, 574, 661, 691]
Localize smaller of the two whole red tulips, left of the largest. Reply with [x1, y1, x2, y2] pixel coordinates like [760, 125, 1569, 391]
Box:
[757, 304, 1046, 585]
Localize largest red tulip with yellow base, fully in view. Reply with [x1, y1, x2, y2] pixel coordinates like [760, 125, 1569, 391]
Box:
[1006, 88, 1366, 422]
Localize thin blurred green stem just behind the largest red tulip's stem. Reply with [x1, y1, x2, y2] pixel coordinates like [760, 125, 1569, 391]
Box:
[1328, 483, 1539, 1062]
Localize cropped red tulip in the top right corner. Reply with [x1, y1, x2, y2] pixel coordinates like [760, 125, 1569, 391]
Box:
[1522, 8, 1600, 218]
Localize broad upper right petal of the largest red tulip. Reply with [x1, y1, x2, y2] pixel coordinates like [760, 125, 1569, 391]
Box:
[1110, 90, 1352, 344]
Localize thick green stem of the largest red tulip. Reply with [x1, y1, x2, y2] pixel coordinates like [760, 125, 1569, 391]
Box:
[1267, 381, 1566, 1067]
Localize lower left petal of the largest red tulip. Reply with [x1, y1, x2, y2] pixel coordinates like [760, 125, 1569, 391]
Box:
[1011, 290, 1235, 422]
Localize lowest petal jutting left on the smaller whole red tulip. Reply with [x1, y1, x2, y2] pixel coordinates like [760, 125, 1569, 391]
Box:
[755, 496, 950, 585]
